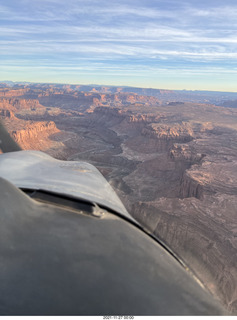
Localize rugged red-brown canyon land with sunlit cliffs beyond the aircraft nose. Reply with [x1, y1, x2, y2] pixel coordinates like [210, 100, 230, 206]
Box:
[0, 84, 237, 313]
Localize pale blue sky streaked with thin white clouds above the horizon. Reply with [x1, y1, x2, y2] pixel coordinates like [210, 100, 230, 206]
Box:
[0, 0, 237, 91]
